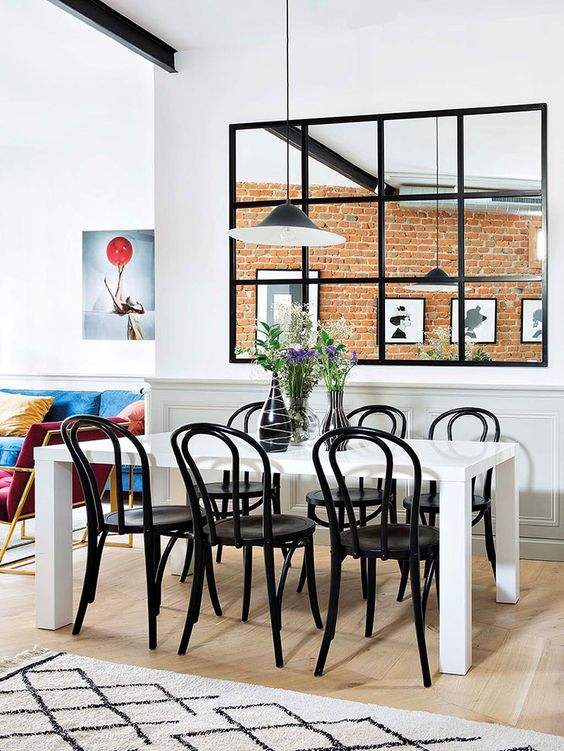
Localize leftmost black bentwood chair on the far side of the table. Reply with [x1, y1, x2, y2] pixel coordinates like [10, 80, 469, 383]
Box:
[185, 402, 280, 568]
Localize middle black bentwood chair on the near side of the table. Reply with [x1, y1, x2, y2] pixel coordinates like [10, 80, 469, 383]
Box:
[170, 423, 323, 667]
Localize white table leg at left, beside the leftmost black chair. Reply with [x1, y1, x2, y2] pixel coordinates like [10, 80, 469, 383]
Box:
[35, 460, 73, 630]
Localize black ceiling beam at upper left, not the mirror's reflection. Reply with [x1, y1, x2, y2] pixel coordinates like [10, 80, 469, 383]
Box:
[49, 0, 176, 73]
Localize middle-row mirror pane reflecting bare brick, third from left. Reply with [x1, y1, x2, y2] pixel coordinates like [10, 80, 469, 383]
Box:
[384, 200, 458, 277]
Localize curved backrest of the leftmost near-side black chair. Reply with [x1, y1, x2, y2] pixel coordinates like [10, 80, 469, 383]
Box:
[61, 415, 153, 534]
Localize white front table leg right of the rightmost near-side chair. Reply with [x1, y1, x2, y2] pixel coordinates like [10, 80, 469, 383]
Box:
[439, 480, 472, 675]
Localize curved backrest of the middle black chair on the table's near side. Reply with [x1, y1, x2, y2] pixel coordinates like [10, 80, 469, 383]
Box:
[170, 422, 272, 547]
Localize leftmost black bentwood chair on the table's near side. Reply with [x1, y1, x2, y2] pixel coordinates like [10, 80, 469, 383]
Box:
[61, 415, 221, 649]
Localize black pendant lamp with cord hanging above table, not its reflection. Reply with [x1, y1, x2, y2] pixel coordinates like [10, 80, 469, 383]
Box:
[229, 0, 346, 247]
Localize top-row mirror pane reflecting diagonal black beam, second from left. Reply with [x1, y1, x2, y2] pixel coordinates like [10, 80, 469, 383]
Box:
[308, 122, 378, 198]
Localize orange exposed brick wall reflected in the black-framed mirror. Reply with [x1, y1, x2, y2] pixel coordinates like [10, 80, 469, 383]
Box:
[236, 183, 541, 361]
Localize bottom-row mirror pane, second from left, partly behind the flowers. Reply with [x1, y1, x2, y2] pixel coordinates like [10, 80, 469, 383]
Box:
[316, 284, 378, 360]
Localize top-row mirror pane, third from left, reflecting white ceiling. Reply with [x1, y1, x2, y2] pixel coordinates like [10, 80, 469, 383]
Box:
[384, 117, 457, 194]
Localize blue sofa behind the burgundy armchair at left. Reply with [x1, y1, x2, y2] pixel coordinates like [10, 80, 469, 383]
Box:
[0, 389, 143, 491]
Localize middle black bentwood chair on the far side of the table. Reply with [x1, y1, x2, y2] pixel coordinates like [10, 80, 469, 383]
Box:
[298, 404, 407, 599]
